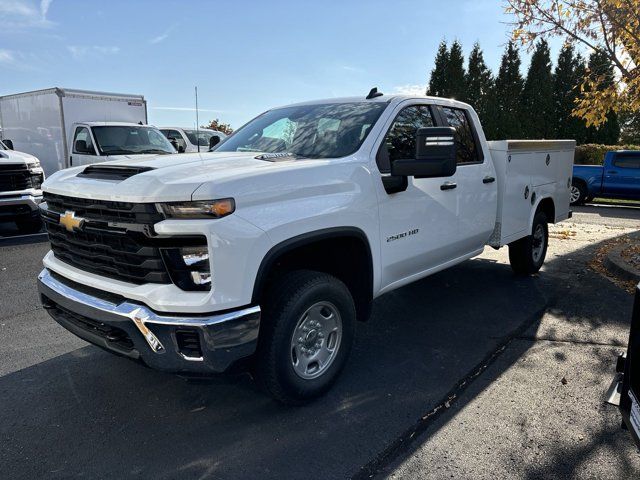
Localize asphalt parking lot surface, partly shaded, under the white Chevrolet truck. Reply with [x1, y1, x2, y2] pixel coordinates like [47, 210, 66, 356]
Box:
[0, 206, 640, 479]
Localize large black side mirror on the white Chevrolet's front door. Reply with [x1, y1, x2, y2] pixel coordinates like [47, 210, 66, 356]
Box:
[391, 127, 457, 178]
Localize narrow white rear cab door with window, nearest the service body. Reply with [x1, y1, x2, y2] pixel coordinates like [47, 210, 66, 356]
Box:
[437, 106, 498, 253]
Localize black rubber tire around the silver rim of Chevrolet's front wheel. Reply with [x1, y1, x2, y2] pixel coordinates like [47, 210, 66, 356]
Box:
[255, 270, 356, 405]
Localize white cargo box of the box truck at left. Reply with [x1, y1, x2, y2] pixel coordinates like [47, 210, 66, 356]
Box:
[0, 88, 155, 176]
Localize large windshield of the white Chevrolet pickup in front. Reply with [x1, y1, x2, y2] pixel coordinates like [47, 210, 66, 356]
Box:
[215, 102, 387, 158]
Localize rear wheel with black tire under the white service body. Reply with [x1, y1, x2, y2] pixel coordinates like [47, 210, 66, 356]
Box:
[509, 211, 549, 275]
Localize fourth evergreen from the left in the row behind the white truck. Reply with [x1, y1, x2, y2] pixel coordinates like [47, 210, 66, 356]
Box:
[494, 42, 524, 139]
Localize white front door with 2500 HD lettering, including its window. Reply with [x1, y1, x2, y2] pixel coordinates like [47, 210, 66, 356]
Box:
[375, 103, 460, 289]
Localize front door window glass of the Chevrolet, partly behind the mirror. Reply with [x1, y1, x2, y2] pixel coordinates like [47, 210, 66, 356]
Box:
[376, 105, 435, 173]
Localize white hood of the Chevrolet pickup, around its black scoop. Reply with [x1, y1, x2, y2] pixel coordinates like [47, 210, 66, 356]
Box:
[43, 152, 312, 202]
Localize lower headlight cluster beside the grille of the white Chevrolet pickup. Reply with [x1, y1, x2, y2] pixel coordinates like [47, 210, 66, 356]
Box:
[162, 245, 211, 291]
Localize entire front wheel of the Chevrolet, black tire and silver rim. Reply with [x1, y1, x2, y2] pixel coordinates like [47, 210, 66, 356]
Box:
[255, 270, 356, 405]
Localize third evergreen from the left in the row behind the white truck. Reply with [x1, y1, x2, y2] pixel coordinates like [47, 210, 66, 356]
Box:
[465, 42, 496, 138]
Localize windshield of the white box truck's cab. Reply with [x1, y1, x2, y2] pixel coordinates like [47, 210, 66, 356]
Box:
[93, 125, 176, 155]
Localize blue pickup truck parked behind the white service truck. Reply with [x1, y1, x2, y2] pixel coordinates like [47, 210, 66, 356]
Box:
[571, 150, 640, 205]
